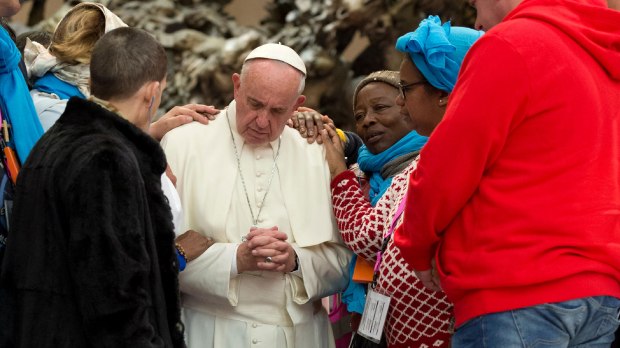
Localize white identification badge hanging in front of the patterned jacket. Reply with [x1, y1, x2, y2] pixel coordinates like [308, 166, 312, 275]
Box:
[357, 289, 390, 343]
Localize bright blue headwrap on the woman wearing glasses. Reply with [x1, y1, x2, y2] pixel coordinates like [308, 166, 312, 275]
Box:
[396, 16, 483, 92]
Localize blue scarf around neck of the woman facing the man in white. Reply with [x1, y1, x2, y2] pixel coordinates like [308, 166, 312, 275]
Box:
[357, 131, 428, 206]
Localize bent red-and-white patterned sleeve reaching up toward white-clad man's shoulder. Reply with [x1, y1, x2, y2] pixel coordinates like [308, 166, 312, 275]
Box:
[331, 167, 410, 262]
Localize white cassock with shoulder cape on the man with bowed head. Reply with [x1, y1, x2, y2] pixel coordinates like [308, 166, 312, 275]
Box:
[162, 101, 351, 348]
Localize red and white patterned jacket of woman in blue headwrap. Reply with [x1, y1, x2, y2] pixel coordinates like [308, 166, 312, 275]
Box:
[331, 161, 452, 348]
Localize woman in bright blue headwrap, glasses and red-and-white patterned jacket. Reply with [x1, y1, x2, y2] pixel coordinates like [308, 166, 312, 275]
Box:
[321, 16, 482, 347]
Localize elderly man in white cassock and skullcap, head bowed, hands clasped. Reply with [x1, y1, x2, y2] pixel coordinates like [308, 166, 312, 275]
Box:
[162, 44, 351, 348]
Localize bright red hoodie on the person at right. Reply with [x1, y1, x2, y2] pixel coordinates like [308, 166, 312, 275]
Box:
[395, 0, 620, 326]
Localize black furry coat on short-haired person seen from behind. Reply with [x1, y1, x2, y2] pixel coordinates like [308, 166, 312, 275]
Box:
[0, 98, 184, 348]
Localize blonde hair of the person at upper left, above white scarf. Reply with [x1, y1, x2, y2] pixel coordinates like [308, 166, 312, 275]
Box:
[49, 6, 105, 64]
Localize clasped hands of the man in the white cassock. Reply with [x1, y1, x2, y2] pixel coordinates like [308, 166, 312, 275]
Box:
[237, 226, 295, 273]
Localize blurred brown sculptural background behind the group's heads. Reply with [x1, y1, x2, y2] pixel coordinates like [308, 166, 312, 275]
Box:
[9, 0, 475, 129]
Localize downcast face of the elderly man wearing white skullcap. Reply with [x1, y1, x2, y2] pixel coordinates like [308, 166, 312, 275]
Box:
[233, 59, 305, 145]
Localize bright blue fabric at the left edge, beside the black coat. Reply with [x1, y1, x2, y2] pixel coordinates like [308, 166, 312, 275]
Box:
[0, 28, 43, 163]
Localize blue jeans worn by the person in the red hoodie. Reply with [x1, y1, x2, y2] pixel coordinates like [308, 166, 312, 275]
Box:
[452, 296, 620, 348]
